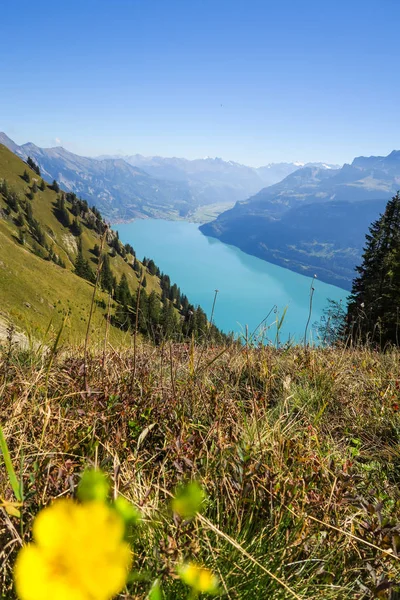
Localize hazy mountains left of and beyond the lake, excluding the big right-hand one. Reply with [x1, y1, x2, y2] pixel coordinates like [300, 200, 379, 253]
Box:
[0, 133, 333, 222]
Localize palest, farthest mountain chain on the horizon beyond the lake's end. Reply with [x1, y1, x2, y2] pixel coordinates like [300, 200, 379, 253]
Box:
[99, 154, 337, 209]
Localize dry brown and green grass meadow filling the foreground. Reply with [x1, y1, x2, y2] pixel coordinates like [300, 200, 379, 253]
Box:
[0, 343, 400, 599]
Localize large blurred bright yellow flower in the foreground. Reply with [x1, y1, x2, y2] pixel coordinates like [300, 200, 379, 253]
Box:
[14, 500, 132, 600]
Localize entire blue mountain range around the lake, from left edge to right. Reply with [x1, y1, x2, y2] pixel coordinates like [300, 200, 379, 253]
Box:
[0, 133, 394, 289]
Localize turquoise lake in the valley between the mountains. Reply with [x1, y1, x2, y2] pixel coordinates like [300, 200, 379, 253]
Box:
[115, 219, 348, 342]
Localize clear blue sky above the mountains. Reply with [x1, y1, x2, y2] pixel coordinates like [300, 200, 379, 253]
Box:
[0, 0, 400, 166]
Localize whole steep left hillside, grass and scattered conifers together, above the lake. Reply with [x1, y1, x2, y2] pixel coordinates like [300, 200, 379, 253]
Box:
[0, 144, 220, 344]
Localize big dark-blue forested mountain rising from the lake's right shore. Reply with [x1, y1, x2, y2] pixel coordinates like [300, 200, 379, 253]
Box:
[201, 151, 400, 288]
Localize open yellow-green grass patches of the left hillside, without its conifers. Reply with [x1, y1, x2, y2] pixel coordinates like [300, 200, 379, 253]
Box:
[0, 145, 161, 343]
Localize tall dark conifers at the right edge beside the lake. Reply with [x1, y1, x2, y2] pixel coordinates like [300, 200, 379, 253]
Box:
[347, 193, 400, 347]
